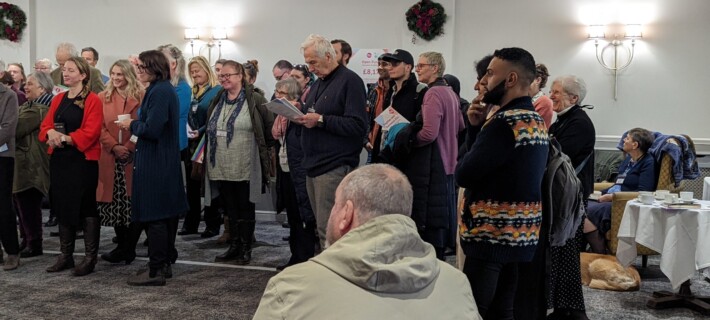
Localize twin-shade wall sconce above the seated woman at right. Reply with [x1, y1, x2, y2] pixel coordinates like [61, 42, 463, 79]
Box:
[588, 24, 643, 100]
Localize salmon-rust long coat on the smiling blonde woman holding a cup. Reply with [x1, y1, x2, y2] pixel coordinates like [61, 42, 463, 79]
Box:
[96, 91, 143, 202]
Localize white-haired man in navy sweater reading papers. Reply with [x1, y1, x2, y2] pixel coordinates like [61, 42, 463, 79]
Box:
[296, 35, 367, 248]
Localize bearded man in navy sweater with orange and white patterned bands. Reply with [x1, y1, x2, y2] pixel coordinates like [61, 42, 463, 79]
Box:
[455, 48, 549, 319]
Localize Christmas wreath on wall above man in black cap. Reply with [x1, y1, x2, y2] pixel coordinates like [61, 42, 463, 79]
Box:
[406, 0, 446, 42]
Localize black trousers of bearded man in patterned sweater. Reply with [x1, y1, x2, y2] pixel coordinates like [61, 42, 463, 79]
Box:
[463, 255, 518, 320]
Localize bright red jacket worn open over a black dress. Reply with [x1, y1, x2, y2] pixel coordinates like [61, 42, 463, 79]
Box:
[39, 92, 103, 161]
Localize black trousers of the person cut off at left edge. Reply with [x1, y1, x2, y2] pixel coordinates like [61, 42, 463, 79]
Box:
[0, 157, 20, 255]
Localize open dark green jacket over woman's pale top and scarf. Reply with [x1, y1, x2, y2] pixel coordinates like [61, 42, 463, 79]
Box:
[205, 85, 276, 193]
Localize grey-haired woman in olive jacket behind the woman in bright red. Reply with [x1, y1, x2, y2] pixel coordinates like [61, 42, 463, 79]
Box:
[12, 72, 54, 258]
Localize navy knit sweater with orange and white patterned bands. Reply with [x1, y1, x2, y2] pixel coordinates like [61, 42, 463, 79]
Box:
[455, 97, 549, 263]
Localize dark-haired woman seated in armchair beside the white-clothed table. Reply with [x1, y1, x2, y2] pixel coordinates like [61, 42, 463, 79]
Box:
[584, 128, 656, 254]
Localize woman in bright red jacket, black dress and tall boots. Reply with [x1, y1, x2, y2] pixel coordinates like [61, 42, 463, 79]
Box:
[39, 57, 103, 276]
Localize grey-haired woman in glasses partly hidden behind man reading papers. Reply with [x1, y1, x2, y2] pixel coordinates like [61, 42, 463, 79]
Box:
[271, 78, 318, 270]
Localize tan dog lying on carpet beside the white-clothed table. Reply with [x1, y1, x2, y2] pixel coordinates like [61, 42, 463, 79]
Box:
[579, 252, 641, 291]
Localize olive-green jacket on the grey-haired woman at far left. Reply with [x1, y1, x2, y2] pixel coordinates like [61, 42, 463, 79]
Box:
[12, 101, 49, 196]
